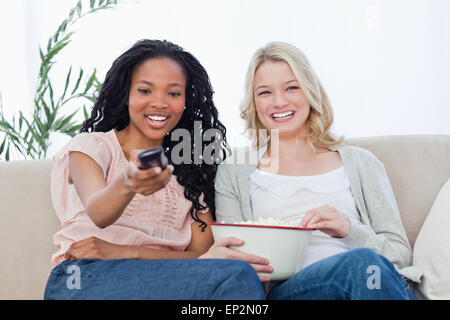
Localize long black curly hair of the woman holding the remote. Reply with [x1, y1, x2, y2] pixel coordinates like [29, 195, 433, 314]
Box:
[80, 39, 229, 231]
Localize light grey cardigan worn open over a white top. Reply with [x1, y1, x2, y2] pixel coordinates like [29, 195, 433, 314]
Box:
[215, 145, 422, 282]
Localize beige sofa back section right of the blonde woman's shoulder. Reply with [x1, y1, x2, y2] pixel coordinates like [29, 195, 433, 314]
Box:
[348, 135, 450, 247]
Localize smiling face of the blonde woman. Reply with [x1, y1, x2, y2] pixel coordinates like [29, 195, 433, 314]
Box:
[253, 61, 310, 138]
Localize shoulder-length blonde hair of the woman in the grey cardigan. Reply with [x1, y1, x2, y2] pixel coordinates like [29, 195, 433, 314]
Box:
[240, 42, 344, 149]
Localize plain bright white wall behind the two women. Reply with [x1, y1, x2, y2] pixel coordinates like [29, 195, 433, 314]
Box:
[0, 0, 450, 160]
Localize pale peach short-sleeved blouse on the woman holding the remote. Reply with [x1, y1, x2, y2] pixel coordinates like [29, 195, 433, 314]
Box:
[51, 130, 201, 267]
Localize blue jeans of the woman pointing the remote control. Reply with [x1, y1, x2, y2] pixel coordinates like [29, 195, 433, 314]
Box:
[44, 259, 265, 300]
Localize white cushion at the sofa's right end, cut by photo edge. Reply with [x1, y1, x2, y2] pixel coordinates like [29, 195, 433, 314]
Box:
[413, 180, 450, 300]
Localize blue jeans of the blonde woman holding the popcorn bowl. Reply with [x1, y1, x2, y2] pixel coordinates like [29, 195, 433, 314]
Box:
[267, 248, 416, 300]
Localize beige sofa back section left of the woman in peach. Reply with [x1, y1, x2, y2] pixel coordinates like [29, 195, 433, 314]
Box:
[0, 160, 59, 299]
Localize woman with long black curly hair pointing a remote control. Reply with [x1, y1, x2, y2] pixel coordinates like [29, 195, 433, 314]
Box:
[44, 40, 264, 299]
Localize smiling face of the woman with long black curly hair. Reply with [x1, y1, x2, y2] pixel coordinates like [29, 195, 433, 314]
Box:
[128, 57, 186, 146]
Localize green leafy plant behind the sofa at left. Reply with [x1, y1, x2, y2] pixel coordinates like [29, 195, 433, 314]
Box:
[0, 0, 117, 161]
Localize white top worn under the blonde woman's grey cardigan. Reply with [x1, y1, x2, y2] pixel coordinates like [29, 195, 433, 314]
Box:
[250, 166, 361, 268]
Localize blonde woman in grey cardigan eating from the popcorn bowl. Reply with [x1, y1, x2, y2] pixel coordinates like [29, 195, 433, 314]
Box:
[199, 42, 420, 299]
